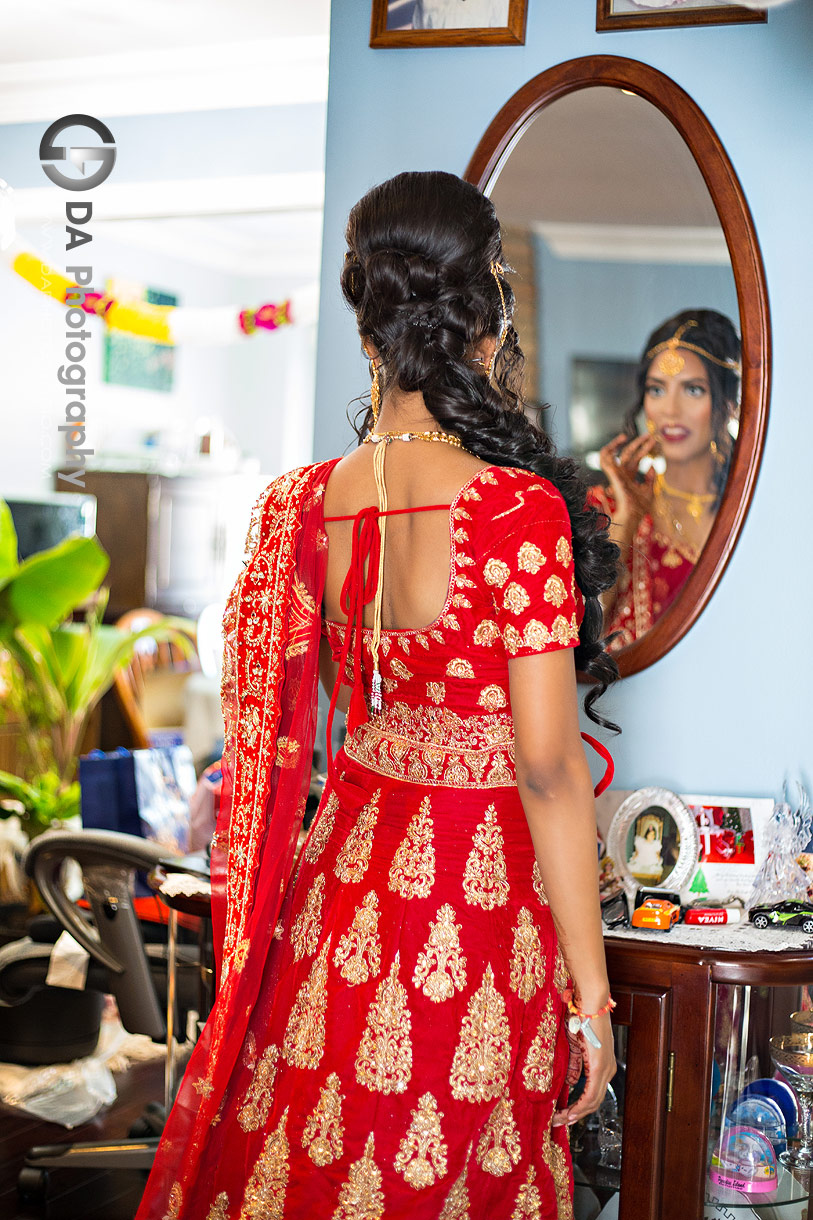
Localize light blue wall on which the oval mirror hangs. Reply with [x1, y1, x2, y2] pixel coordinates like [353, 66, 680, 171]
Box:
[315, 0, 813, 795]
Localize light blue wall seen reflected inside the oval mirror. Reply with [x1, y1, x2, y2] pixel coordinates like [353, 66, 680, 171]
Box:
[529, 234, 740, 451]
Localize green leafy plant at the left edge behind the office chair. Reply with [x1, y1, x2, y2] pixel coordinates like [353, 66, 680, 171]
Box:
[0, 500, 194, 838]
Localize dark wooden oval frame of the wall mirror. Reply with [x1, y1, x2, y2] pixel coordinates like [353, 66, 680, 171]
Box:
[464, 55, 770, 677]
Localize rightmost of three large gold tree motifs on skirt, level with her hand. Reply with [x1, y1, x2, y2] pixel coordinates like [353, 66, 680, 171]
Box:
[449, 963, 511, 1102]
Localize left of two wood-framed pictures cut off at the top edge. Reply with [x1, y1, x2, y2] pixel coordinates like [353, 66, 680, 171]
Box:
[370, 0, 527, 46]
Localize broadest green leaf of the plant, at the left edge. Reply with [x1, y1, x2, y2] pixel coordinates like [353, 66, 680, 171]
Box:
[0, 538, 110, 627]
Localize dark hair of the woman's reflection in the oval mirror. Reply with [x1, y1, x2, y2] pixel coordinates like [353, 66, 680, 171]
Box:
[624, 309, 742, 509]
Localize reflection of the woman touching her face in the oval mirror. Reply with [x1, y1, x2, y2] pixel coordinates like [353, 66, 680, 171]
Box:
[591, 310, 740, 649]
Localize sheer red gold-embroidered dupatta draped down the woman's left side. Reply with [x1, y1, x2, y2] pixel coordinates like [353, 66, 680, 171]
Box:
[137, 461, 334, 1220]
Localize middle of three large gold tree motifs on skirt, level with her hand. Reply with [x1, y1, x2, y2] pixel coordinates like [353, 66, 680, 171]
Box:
[355, 953, 413, 1093]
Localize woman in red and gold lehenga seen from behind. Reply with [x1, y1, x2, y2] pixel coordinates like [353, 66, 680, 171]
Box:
[138, 172, 615, 1220]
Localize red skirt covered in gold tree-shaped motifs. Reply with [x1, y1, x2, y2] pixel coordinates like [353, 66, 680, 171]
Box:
[172, 705, 571, 1220]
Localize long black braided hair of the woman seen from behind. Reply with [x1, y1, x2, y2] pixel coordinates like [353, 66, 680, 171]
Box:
[342, 171, 618, 731]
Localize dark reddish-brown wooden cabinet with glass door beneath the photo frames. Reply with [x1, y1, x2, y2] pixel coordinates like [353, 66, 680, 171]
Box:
[573, 935, 813, 1220]
